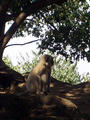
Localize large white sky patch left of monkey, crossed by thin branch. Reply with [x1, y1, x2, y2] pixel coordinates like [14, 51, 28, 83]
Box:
[3, 36, 38, 65]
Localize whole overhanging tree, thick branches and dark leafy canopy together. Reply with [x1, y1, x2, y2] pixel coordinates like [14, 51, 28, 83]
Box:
[0, 0, 90, 64]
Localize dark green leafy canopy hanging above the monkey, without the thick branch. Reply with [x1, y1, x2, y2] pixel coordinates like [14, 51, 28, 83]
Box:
[8, 0, 90, 61]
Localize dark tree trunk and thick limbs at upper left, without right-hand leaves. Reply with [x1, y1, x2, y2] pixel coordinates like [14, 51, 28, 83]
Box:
[0, 0, 67, 64]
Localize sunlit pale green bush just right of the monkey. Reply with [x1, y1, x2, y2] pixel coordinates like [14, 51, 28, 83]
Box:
[52, 56, 81, 84]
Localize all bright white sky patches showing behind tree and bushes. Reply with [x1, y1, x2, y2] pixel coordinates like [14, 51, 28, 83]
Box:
[3, 0, 90, 75]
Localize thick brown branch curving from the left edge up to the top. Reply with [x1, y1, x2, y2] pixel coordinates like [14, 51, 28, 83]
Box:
[0, 0, 67, 48]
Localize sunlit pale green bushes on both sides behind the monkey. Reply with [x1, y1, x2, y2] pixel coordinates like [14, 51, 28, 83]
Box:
[3, 52, 90, 84]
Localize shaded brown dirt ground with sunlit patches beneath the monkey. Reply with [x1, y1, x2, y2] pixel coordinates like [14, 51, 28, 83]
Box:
[0, 79, 90, 120]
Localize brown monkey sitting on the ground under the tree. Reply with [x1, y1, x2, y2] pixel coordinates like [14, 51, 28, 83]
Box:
[26, 54, 54, 94]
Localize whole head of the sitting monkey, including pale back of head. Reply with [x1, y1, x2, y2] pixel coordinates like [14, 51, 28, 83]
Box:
[41, 54, 54, 67]
